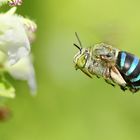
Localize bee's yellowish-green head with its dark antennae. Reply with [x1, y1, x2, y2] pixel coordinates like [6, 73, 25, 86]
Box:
[73, 34, 92, 77]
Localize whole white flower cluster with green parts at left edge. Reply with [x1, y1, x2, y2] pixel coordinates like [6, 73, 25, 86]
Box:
[0, 0, 37, 97]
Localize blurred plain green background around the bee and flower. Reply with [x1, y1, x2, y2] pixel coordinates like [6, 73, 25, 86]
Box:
[0, 0, 140, 140]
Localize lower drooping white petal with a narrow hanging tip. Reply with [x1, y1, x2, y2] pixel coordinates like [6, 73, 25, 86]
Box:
[5, 56, 37, 95]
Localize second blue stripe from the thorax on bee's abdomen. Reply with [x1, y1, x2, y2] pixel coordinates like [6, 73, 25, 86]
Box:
[126, 57, 139, 76]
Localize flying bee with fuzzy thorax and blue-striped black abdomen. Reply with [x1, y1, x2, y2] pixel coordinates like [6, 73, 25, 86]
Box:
[73, 33, 140, 93]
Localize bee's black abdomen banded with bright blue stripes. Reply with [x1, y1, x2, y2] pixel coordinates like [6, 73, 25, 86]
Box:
[116, 51, 140, 88]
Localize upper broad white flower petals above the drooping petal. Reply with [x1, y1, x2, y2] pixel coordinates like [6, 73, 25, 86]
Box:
[0, 7, 36, 65]
